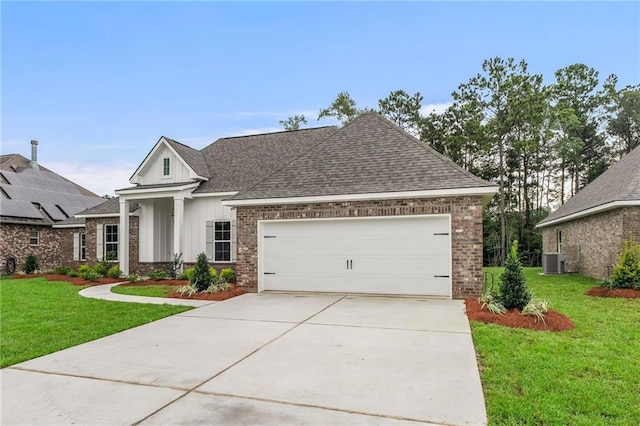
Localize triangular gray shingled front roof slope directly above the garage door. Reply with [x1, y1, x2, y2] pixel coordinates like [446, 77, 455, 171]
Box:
[232, 113, 495, 200]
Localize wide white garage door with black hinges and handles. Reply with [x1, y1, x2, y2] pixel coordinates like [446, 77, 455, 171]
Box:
[258, 215, 451, 297]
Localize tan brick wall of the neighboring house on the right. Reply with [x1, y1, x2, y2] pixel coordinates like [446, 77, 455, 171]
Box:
[542, 207, 640, 280]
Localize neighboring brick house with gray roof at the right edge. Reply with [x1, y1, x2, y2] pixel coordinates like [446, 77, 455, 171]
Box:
[537, 147, 640, 280]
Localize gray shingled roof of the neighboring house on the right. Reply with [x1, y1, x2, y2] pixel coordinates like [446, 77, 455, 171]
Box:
[537, 146, 640, 227]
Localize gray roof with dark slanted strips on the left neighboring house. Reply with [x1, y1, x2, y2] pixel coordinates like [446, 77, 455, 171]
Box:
[0, 154, 102, 224]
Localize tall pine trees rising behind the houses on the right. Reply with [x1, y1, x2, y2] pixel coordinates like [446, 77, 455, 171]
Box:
[280, 57, 640, 265]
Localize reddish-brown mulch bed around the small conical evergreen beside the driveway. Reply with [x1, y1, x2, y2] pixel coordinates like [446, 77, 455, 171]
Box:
[464, 299, 575, 331]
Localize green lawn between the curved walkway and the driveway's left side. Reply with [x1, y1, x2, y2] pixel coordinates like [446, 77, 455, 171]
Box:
[0, 278, 191, 367]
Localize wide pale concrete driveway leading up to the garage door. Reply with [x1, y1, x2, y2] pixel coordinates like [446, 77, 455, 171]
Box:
[0, 293, 486, 425]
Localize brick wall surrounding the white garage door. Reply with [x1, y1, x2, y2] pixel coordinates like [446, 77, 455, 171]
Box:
[236, 196, 483, 298]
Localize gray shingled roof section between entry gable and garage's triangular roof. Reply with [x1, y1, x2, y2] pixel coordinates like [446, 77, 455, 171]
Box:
[194, 126, 336, 193]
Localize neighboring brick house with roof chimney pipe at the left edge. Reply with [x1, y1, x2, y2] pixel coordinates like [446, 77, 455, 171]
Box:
[0, 141, 104, 270]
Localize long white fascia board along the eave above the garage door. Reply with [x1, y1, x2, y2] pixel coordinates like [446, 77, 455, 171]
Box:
[222, 186, 498, 206]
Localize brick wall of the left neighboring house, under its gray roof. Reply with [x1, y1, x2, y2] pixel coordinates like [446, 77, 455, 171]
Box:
[0, 223, 81, 271]
